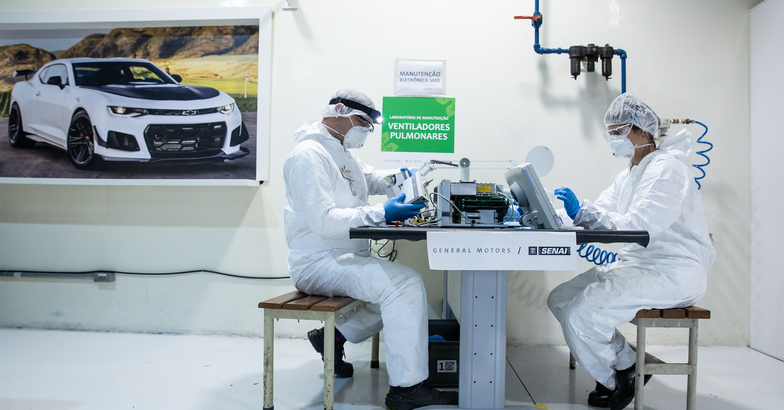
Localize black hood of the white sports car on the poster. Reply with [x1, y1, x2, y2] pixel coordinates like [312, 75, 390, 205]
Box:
[82, 85, 220, 101]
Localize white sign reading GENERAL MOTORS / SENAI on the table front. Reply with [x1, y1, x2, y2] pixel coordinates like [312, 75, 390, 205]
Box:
[427, 230, 577, 270]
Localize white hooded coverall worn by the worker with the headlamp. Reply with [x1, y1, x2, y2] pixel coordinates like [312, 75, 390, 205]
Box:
[283, 121, 428, 387]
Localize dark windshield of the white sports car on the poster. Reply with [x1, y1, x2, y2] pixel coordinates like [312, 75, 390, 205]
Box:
[73, 61, 177, 87]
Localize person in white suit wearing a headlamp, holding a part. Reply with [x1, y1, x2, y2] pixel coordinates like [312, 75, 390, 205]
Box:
[283, 90, 458, 410]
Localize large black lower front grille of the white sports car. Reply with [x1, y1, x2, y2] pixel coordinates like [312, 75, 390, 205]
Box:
[144, 122, 227, 158]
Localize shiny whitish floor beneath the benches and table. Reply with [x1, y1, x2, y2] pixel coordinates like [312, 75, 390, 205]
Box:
[0, 329, 784, 410]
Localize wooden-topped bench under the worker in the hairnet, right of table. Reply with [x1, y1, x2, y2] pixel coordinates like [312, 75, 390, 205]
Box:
[569, 306, 710, 410]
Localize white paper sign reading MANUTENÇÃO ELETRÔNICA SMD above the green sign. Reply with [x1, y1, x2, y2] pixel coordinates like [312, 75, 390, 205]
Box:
[395, 60, 446, 97]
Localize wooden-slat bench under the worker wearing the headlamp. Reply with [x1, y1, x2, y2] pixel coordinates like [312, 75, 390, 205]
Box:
[259, 291, 378, 410]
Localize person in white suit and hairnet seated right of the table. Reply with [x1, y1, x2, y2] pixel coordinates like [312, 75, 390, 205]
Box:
[547, 93, 716, 410]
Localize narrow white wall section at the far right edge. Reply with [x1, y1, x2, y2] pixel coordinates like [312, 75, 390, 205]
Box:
[749, 0, 784, 360]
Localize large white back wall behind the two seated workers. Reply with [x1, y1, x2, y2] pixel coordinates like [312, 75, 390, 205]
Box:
[0, 0, 758, 345]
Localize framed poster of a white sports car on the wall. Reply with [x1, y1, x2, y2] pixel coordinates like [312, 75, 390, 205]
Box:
[0, 10, 271, 184]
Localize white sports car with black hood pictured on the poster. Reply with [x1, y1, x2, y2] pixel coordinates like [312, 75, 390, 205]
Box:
[8, 58, 250, 169]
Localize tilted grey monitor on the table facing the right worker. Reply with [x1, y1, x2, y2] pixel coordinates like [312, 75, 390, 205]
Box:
[504, 162, 561, 229]
